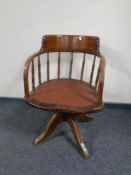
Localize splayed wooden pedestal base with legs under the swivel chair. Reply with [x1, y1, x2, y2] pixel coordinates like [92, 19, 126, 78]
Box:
[33, 112, 94, 159]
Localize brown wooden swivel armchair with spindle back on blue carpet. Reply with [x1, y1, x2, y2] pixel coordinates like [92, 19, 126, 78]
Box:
[24, 35, 105, 159]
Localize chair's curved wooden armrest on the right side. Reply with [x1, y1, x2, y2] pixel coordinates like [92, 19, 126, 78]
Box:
[97, 53, 106, 104]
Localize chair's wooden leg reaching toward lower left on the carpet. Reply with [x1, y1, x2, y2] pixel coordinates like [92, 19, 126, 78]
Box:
[33, 112, 63, 145]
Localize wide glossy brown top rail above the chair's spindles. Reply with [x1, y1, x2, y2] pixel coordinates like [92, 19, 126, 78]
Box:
[40, 35, 99, 55]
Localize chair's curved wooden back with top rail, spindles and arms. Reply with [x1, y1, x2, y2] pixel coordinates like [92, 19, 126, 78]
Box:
[24, 35, 105, 106]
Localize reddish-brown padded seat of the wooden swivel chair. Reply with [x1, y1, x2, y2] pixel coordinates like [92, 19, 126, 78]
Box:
[27, 79, 100, 113]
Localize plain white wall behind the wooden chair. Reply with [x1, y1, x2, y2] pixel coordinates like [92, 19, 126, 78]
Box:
[0, 0, 131, 103]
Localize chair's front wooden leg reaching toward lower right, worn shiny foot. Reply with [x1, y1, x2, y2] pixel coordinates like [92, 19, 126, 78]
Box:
[67, 116, 89, 159]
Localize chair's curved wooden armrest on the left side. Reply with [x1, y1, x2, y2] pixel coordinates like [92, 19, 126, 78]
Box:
[23, 51, 40, 98]
